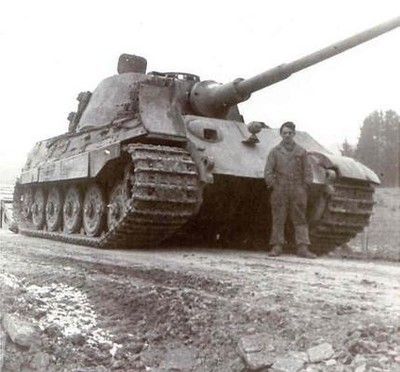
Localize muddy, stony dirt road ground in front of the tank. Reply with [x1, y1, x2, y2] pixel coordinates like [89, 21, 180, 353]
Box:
[0, 232, 400, 371]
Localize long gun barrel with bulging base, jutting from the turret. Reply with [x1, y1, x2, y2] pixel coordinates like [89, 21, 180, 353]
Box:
[190, 17, 400, 117]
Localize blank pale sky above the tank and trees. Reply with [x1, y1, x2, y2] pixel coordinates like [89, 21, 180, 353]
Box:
[0, 0, 400, 181]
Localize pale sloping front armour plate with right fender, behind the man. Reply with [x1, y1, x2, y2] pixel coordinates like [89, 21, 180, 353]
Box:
[185, 115, 380, 184]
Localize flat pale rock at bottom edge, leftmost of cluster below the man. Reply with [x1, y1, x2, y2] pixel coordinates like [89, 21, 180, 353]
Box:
[238, 333, 274, 371]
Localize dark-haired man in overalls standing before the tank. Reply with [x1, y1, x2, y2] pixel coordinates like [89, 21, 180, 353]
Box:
[264, 121, 316, 258]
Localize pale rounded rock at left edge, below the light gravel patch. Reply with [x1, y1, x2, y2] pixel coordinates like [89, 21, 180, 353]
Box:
[3, 314, 40, 347]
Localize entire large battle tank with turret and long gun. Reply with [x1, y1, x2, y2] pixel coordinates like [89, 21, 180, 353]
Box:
[14, 17, 400, 254]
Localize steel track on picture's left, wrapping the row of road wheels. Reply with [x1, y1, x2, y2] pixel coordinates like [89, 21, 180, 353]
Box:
[14, 144, 201, 248]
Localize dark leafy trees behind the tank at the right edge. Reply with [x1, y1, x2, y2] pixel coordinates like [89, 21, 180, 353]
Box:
[340, 110, 400, 187]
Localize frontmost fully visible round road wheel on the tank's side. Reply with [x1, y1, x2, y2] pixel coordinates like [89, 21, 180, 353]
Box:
[83, 184, 106, 236]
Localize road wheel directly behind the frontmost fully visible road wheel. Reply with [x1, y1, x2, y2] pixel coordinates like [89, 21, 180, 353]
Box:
[63, 186, 82, 234]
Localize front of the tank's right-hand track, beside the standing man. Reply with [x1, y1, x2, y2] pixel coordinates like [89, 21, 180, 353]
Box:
[310, 179, 374, 254]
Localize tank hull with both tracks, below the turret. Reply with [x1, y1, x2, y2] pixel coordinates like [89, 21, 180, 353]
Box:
[14, 115, 379, 254]
